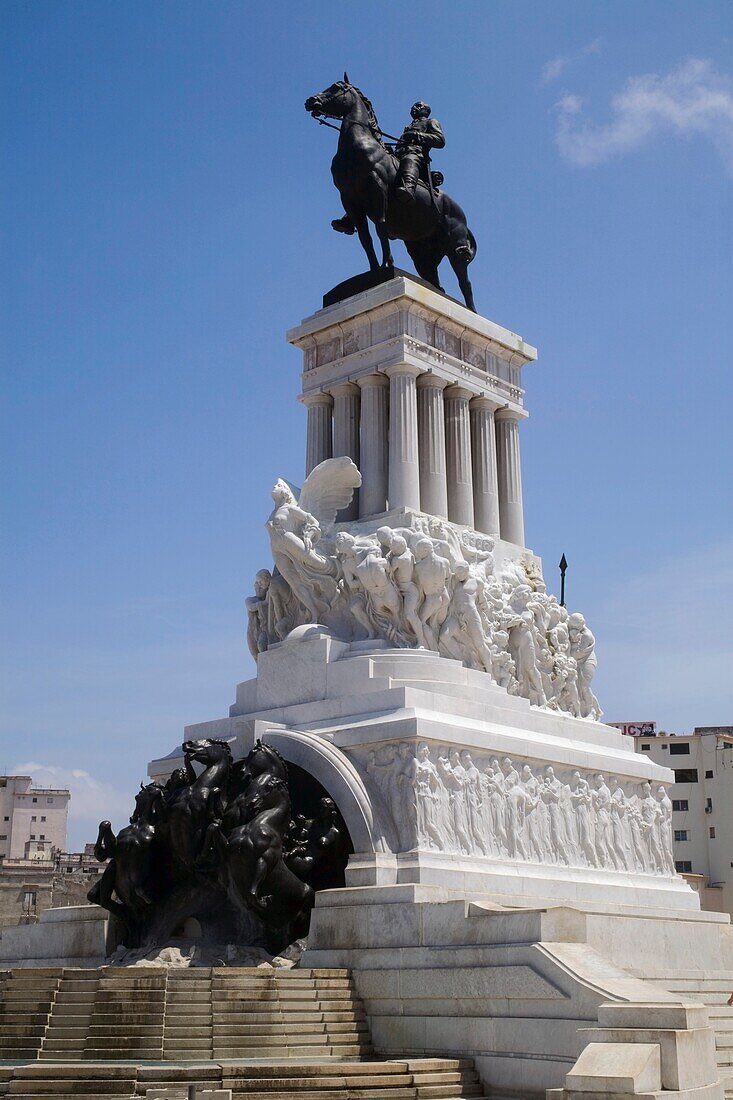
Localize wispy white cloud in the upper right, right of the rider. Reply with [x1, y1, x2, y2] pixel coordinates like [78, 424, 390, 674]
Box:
[556, 58, 733, 175]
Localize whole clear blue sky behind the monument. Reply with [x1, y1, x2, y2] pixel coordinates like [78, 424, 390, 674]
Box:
[0, 0, 733, 845]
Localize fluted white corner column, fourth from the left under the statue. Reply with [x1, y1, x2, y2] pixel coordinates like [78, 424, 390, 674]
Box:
[384, 363, 423, 512]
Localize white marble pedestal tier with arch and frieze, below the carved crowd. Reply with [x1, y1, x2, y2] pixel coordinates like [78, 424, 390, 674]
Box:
[149, 626, 699, 912]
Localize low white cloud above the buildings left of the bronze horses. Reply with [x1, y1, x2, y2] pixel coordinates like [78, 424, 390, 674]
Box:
[11, 760, 134, 846]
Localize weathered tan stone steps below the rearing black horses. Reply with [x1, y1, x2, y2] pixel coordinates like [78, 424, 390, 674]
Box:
[0, 967, 483, 1100]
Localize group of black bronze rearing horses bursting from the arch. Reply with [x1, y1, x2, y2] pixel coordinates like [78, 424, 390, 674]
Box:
[88, 738, 348, 952]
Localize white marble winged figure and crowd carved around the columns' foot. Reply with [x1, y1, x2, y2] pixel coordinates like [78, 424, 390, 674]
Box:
[253, 458, 601, 721]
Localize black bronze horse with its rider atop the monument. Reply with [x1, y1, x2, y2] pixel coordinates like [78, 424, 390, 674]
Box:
[305, 73, 477, 312]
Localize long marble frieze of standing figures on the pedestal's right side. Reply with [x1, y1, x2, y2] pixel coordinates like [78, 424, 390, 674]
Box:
[355, 741, 675, 876]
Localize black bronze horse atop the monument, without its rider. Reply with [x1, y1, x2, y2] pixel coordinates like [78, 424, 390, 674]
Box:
[305, 73, 477, 312]
